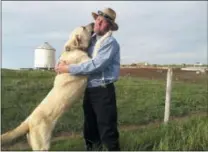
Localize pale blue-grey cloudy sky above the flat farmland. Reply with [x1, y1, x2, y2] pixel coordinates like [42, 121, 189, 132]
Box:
[2, 1, 208, 68]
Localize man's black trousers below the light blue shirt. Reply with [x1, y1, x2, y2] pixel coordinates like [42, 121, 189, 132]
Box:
[83, 83, 120, 151]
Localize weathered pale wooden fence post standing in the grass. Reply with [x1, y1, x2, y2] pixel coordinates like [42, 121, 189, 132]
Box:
[164, 68, 173, 123]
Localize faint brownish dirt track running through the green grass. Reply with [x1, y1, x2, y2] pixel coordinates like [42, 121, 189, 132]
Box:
[1, 112, 208, 151]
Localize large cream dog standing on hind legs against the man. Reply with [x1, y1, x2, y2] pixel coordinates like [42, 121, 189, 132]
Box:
[1, 23, 111, 150]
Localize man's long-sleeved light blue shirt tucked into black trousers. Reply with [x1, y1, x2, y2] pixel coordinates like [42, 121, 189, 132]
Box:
[69, 34, 120, 88]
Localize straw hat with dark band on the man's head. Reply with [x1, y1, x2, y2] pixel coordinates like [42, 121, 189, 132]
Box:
[92, 8, 118, 31]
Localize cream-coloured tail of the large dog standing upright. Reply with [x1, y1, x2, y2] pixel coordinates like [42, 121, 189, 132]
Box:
[1, 121, 29, 145]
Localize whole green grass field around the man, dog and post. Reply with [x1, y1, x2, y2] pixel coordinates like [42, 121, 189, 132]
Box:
[1, 70, 208, 150]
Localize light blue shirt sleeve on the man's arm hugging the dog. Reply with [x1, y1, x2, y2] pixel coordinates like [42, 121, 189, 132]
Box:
[69, 38, 119, 75]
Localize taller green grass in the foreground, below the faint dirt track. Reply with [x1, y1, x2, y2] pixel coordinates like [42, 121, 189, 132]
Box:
[34, 116, 208, 151]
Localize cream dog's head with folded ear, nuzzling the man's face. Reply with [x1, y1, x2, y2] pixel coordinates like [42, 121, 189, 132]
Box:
[65, 23, 94, 51]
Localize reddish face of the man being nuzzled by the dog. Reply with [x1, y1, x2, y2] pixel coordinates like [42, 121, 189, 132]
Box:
[94, 16, 111, 35]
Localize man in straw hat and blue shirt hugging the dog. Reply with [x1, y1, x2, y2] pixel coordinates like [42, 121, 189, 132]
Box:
[56, 8, 120, 151]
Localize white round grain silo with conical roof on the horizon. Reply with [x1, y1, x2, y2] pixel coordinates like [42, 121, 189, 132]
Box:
[34, 42, 56, 69]
